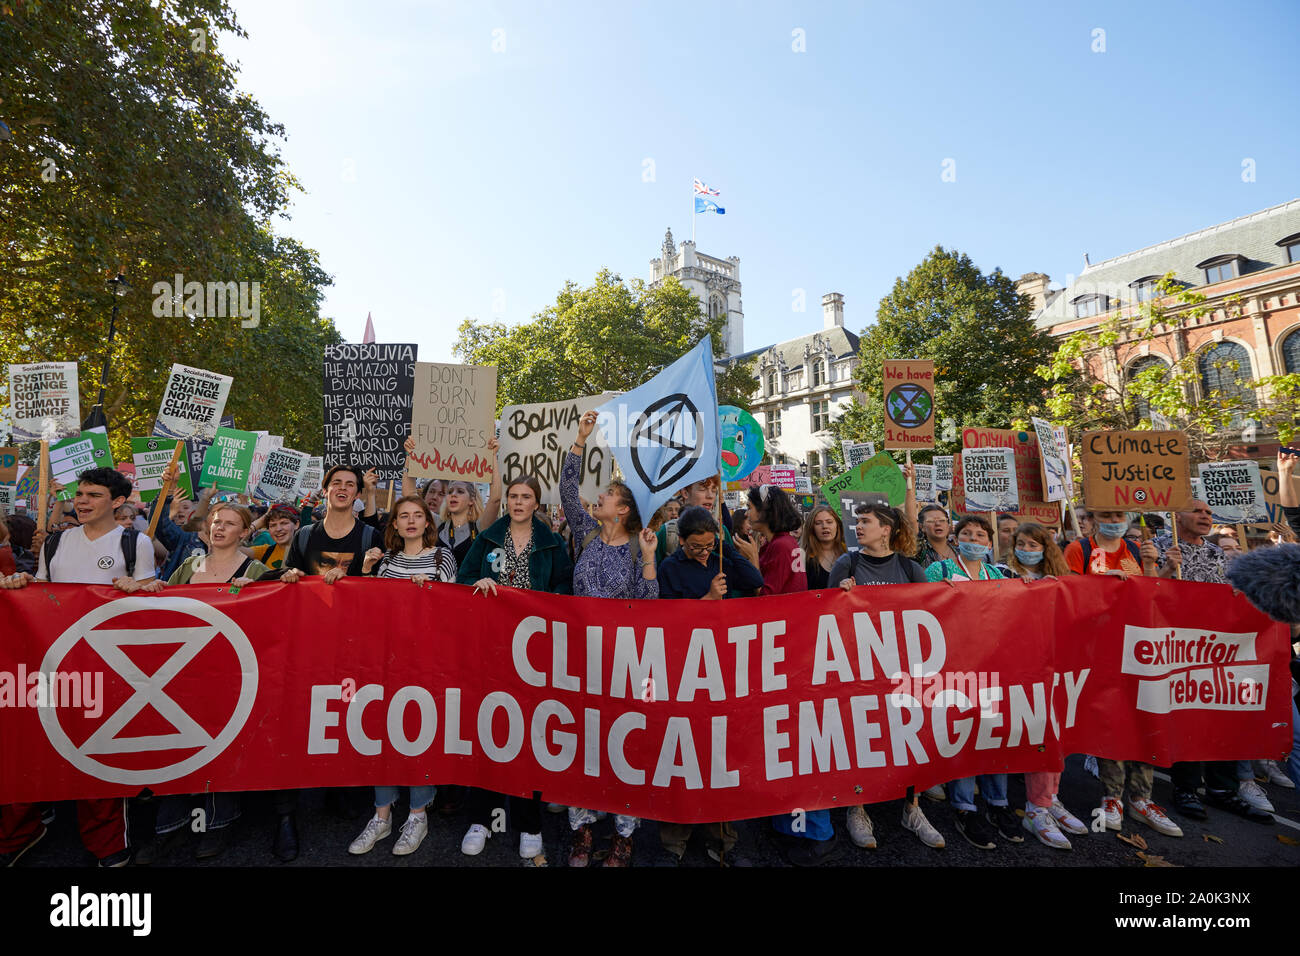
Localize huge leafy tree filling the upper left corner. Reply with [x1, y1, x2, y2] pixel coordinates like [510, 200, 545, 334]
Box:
[0, 0, 338, 455]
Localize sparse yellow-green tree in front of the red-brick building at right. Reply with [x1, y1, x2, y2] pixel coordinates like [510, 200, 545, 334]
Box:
[1034, 273, 1300, 460]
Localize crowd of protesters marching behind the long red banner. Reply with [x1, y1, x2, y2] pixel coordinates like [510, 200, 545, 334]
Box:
[0, 444, 1300, 868]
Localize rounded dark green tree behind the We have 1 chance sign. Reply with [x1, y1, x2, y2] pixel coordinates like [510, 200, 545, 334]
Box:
[832, 246, 1054, 467]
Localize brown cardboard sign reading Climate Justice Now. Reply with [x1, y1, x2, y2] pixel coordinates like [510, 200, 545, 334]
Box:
[1079, 432, 1192, 511]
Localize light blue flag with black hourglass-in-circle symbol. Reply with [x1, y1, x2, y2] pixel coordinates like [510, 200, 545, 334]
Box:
[597, 336, 722, 525]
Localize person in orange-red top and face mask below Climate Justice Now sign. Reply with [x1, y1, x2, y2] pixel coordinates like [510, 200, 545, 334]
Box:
[1065, 511, 1183, 836]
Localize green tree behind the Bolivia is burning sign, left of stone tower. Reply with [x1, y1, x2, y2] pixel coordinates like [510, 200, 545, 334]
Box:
[452, 269, 754, 411]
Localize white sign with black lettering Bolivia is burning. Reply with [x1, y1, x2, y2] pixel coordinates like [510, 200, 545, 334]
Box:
[497, 392, 619, 505]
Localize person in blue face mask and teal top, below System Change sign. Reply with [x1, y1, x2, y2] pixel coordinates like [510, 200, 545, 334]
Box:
[926, 515, 1024, 849]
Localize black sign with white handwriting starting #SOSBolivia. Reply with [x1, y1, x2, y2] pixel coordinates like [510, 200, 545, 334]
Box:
[322, 342, 417, 481]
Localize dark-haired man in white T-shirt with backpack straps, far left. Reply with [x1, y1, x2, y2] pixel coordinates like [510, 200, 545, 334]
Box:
[0, 468, 153, 866]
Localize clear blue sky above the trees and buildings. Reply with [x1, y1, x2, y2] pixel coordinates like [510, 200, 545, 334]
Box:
[225, 0, 1300, 360]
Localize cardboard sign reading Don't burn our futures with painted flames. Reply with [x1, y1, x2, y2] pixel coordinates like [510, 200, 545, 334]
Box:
[410, 362, 497, 481]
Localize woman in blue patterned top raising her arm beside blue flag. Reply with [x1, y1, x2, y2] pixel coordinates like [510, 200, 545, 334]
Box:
[560, 411, 659, 866]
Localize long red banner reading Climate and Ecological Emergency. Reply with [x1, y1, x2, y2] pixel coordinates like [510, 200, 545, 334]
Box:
[0, 578, 1291, 822]
